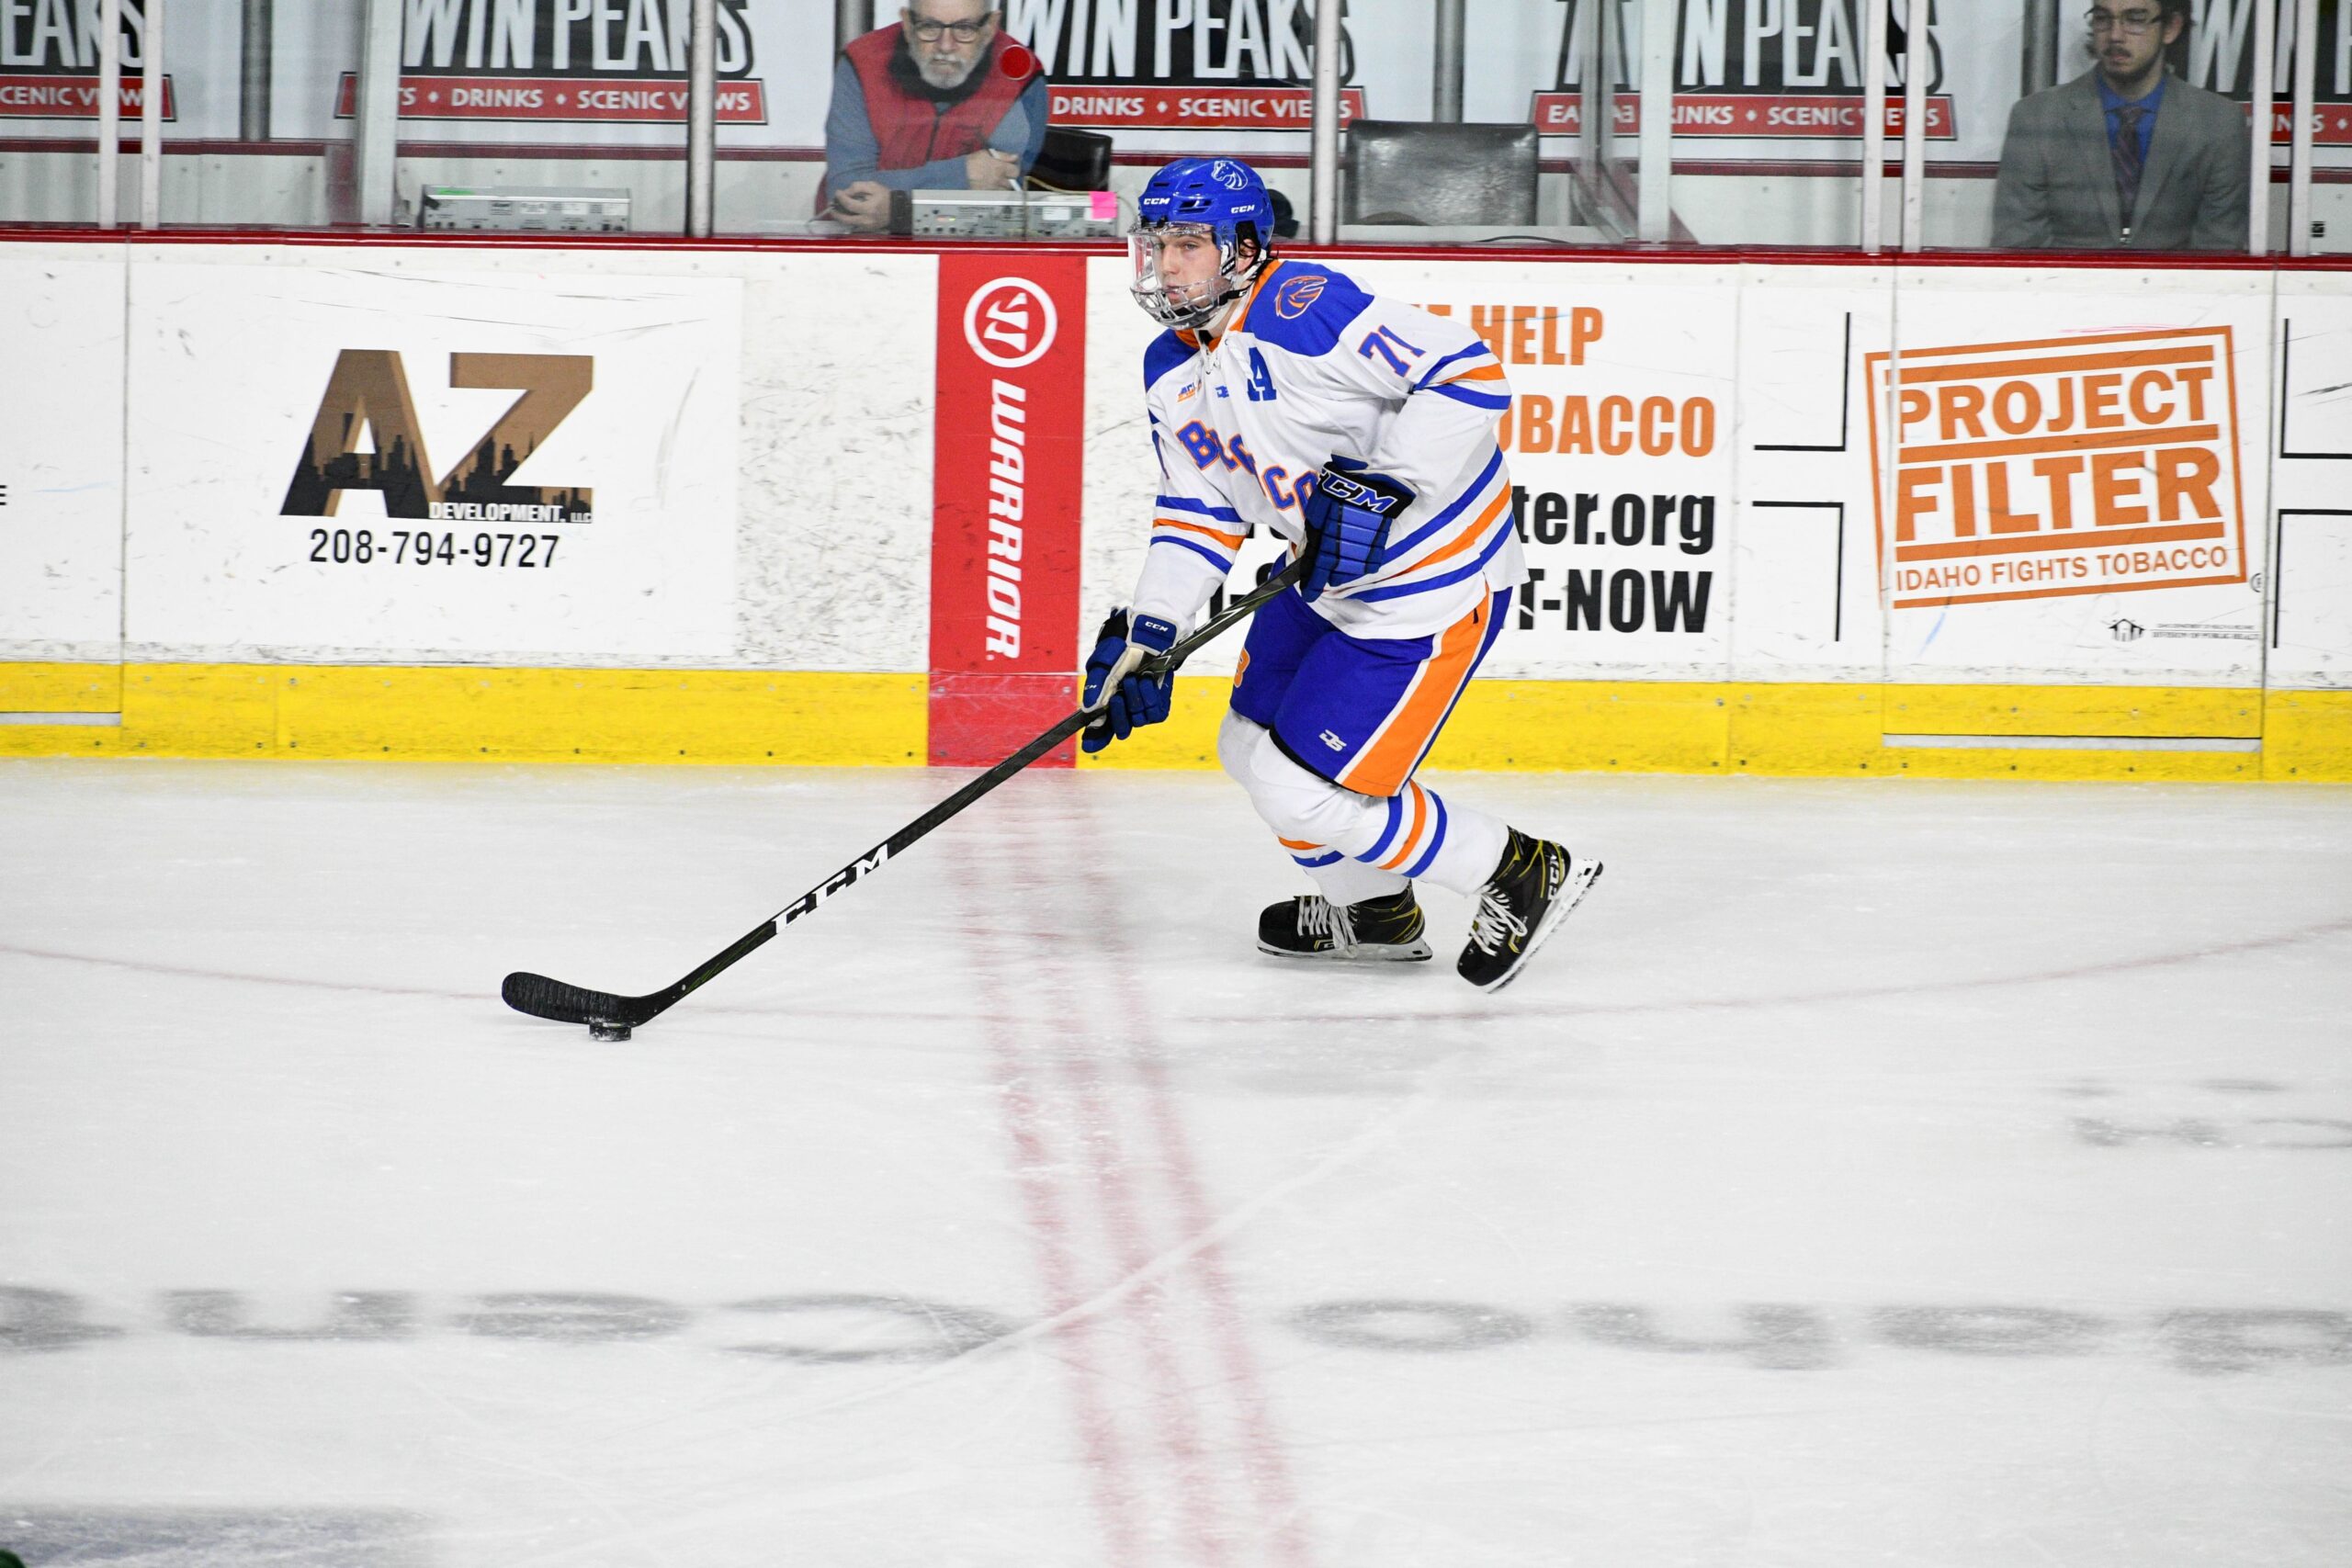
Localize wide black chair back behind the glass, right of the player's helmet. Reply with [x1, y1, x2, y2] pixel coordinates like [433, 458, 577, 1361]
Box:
[1340, 120, 1536, 223]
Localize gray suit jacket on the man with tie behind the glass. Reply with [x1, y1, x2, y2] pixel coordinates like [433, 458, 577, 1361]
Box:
[1992, 66, 2253, 252]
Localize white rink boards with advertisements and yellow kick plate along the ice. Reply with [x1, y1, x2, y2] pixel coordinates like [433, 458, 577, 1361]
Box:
[0, 237, 2352, 778]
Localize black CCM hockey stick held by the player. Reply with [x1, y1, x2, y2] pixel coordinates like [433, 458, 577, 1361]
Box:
[499, 555, 1306, 1039]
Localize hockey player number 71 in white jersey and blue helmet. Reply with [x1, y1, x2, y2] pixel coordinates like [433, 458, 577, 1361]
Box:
[1080, 157, 1601, 989]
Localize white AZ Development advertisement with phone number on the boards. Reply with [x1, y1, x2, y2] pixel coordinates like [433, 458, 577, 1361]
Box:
[125, 259, 741, 656]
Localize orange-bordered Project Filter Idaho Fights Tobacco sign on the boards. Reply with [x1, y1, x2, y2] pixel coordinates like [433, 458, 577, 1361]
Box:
[1868, 327, 2246, 609]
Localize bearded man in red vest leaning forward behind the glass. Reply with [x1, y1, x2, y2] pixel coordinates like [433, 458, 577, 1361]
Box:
[819, 0, 1046, 231]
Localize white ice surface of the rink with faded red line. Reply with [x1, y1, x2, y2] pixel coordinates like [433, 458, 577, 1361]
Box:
[0, 761, 2352, 1568]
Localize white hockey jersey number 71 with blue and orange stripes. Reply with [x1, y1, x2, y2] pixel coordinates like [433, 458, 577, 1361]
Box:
[1134, 261, 1526, 637]
